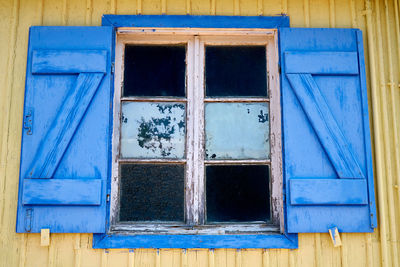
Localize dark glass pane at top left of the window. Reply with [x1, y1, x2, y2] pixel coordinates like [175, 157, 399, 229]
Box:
[123, 45, 186, 97]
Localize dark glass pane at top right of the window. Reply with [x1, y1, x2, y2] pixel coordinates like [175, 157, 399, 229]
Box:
[205, 46, 267, 97]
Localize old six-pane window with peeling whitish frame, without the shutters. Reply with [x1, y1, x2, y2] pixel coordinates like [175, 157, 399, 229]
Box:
[110, 28, 283, 234]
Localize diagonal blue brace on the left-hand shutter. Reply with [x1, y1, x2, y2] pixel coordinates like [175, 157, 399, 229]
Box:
[26, 73, 103, 178]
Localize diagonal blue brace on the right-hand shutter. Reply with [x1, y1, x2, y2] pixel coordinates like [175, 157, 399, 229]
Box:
[286, 73, 364, 178]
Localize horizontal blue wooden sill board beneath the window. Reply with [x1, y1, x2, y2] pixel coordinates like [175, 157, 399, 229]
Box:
[93, 234, 298, 249]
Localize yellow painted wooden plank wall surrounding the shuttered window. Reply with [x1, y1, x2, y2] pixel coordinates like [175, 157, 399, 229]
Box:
[0, 0, 400, 267]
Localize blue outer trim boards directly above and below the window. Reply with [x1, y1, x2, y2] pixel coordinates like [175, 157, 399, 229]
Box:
[93, 15, 298, 249]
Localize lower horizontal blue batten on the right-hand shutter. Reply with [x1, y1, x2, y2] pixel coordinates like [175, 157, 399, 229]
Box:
[289, 179, 368, 205]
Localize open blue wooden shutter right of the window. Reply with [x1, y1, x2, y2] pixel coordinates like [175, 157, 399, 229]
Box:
[280, 28, 377, 233]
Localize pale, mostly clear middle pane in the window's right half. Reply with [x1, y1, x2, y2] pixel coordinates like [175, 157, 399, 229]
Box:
[205, 103, 269, 159]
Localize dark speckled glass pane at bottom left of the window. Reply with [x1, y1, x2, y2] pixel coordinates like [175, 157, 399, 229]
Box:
[119, 164, 185, 221]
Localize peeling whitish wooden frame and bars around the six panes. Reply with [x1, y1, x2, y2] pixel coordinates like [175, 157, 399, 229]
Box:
[109, 28, 284, 234]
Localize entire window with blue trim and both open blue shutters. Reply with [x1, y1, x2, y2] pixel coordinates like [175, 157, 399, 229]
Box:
[16, 15, 377, 251]
